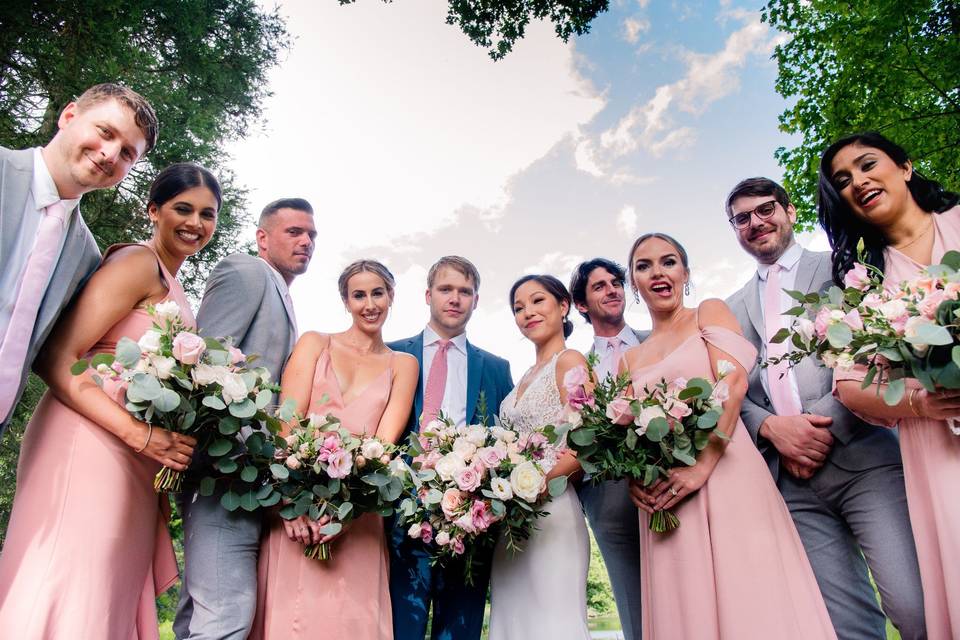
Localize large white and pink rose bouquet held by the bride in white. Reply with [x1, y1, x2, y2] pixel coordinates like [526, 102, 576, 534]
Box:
[397, 412, 566, 582]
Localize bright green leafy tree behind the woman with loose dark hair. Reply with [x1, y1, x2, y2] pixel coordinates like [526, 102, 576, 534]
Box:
[764, 0, 960, 227]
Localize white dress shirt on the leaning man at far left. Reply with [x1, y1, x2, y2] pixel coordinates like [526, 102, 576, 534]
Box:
[0, 147, 80, 344]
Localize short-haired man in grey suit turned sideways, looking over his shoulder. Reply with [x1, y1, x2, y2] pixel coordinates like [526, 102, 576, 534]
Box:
[173, 198, 317, 640]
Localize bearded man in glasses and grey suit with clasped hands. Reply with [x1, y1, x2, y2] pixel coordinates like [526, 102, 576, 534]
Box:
[726, 178, 926, 640]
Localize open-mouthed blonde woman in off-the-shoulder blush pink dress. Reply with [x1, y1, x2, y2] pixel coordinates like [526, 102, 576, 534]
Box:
[621, 234, 836, 640]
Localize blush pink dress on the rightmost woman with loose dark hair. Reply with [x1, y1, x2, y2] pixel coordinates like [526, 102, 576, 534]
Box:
[834, 207, 960, 640]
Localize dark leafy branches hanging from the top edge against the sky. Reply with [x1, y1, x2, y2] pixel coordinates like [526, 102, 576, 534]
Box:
[339, 0, 610, 60]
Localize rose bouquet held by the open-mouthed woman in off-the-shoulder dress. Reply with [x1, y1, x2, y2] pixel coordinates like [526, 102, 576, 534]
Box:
[564, 357, 733, 533]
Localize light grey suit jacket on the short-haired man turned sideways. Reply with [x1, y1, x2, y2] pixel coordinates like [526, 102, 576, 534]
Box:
[197, 253, 297, 383]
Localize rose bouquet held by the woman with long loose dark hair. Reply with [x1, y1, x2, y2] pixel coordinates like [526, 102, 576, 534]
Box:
[767, 251, 960, 432]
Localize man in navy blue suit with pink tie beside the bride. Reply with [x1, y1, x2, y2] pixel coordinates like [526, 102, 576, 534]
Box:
[388, 256, 513, 640]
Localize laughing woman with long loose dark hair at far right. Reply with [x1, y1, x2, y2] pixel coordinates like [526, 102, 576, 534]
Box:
[819, 133, 960, 640]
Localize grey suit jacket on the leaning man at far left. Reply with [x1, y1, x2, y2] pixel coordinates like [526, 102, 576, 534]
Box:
[0, 147, 100, 435]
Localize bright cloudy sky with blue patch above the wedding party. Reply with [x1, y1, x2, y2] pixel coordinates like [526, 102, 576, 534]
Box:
[230, 0, 826, 380]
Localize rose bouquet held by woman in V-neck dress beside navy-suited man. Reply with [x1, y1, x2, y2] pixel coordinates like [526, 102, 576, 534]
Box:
[262, 403, 403, 560]
